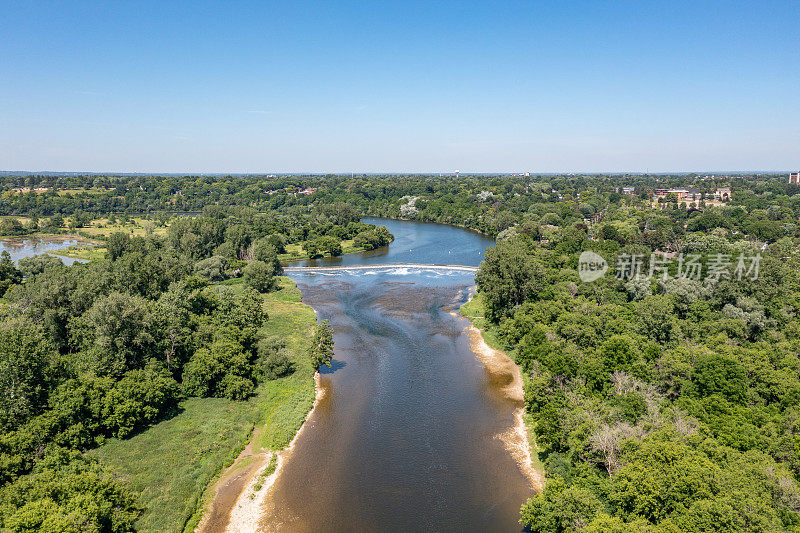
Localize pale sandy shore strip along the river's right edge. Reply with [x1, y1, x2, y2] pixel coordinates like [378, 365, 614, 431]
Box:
[460, 292, 545, 492]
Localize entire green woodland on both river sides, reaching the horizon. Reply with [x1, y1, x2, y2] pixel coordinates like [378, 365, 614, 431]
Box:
[0, 175, 800, 532]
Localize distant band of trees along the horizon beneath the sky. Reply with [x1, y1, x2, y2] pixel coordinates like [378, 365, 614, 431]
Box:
[0, 171, 800, 240]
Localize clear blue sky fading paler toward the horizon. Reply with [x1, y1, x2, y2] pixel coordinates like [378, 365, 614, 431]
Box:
[0, 0, 800, 172]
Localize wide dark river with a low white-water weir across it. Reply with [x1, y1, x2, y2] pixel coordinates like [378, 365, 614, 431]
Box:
[262, 219, 533, 532]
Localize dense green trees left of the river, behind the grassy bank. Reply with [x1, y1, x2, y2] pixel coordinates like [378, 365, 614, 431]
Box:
[0, 201, 391, 532]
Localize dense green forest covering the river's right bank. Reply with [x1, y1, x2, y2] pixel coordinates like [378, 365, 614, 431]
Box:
[476, 219, 800, 532]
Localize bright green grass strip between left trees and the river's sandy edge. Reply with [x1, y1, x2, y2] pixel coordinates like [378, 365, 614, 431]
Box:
[85, 277, 316, 531]
